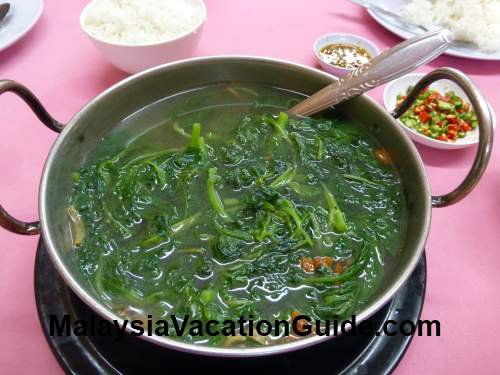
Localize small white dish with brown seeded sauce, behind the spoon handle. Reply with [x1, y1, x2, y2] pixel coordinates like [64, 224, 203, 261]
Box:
[313, 33, 380, 76]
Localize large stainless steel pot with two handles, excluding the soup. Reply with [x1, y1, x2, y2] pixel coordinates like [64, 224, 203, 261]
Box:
[0, 56, 493, 357]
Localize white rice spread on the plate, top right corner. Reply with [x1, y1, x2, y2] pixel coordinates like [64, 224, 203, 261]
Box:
[401, 0, 500, 52]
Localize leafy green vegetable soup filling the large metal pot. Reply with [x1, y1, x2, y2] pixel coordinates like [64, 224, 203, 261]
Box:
[67, 84, 407, 347]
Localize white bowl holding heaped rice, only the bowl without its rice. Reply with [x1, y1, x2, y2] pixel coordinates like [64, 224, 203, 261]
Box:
[80, 0, 207, 73]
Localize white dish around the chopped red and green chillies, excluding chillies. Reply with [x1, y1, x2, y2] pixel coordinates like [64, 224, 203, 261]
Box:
[384, 73, 496, 150]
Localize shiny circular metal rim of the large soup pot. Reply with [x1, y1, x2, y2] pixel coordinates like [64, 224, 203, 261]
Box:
[38, 55, 431, 357]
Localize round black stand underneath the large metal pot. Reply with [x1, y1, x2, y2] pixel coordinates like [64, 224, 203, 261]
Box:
[35, 241, 426, 375]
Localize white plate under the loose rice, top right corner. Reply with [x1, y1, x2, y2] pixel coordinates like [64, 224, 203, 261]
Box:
[368, 0, 500, 61]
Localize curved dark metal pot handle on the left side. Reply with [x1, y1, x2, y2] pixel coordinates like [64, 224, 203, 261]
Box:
[0, 80, 64, 235]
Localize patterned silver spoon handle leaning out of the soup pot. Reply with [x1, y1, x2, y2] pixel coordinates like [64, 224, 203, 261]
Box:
[289, 30, 453, 116]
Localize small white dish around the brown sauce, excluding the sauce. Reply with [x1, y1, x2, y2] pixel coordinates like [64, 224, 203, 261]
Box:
[313, 33, 380, 77]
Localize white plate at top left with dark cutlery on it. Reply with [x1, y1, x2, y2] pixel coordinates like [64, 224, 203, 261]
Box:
[0, 0, 43, 51]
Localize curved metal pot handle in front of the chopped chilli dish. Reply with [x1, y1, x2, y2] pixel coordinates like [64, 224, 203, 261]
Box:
[392, 68, 493, 207]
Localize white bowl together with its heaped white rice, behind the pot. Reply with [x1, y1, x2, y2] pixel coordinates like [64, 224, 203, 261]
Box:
[80, 0, 207, 73]
